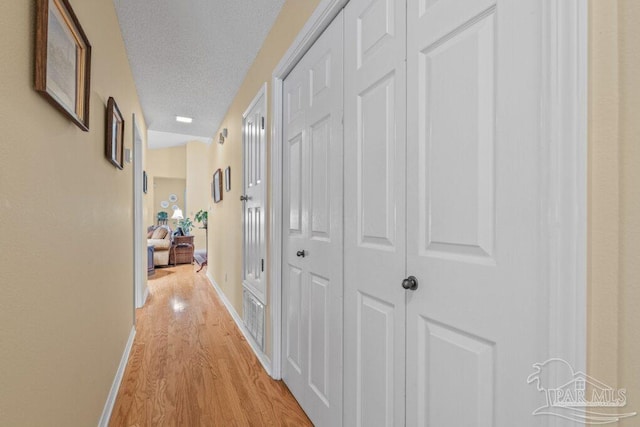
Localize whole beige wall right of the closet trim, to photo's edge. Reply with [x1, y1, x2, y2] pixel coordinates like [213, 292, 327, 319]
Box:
[588, 0, 640, 426]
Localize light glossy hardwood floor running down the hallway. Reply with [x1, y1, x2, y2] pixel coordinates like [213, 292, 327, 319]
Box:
[109, 265, 312, 427]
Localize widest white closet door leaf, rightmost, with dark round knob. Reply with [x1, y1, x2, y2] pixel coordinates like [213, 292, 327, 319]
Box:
[407, 0, 547, 427]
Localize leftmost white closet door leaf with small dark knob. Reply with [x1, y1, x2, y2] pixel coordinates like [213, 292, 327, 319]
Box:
[282, 14, 343, 427]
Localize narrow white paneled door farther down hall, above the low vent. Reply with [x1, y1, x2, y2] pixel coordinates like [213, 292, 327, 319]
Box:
[244, 85, 267, 304]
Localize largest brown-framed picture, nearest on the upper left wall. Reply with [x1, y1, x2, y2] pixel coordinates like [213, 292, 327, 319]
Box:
[35, 0, 91, 131]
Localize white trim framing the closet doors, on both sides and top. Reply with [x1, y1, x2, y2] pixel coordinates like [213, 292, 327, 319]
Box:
[269, 0, 588, 390]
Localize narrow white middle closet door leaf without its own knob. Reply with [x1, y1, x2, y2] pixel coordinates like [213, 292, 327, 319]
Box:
[344, 0, 406, 427]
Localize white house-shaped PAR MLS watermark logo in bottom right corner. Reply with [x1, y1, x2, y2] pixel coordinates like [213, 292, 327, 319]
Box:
[527, 359, 636, 424]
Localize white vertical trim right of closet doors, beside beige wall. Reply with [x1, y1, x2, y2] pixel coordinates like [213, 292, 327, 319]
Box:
[540, 0, 589, 380]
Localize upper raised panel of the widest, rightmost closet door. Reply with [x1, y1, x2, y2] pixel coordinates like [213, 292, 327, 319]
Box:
[418, 13, 495, 263]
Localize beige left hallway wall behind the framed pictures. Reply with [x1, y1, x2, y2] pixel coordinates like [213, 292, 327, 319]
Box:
[0, 0, 146, 426]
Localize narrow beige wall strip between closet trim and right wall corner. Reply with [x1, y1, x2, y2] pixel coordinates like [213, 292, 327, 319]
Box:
[587, 0, 619, 386]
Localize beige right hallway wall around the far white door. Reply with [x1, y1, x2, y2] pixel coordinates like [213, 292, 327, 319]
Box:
[208, 0, 319, 353]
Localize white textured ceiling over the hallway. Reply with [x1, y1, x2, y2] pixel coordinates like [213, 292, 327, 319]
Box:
[113, 0, 284, 148]
